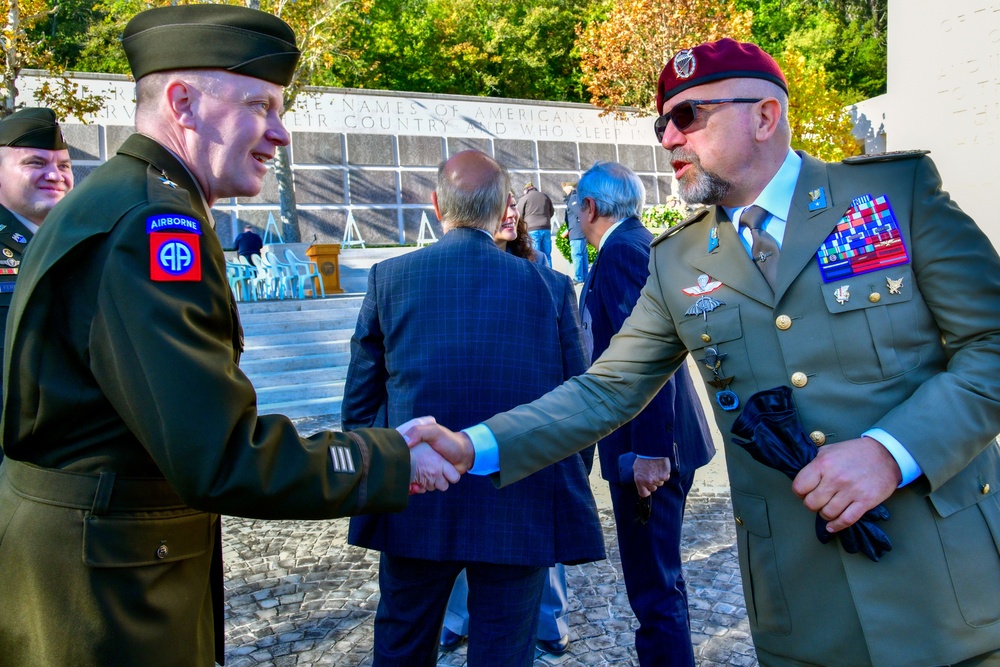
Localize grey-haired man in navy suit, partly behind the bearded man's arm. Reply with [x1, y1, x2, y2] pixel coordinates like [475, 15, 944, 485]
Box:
[577, 162, 715, 667]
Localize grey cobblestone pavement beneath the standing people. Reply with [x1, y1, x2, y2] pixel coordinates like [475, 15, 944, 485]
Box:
[223, 418, 757, 667]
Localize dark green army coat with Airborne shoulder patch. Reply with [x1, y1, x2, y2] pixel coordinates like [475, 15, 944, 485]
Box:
[0, 134, 410, 667]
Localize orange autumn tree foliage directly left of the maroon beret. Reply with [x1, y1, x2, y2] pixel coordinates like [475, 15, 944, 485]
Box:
[577, 0, 753, 113]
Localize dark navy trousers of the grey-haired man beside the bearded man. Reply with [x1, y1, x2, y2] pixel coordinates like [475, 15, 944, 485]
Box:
[609, 472, 694, 667]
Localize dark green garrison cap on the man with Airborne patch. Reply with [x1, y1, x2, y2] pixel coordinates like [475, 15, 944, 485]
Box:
[122, 5, 301, 86]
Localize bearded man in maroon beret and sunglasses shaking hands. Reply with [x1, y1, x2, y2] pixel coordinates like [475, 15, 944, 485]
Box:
[410, 40, 1000, 667]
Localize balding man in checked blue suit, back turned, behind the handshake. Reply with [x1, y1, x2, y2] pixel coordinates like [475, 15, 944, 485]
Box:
[342, 151, 604, 667]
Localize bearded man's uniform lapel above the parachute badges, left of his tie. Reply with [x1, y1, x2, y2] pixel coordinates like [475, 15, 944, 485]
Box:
[691, 206, 772, 305]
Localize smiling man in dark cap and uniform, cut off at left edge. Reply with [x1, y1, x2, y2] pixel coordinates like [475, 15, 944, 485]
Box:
[0, 107, 73, 422]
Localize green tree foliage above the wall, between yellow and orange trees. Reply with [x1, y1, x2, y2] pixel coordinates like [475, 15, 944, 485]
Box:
[317, 0, 591, 101]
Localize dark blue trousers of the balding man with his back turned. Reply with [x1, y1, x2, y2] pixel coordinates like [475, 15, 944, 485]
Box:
[373, 553, 548, 667]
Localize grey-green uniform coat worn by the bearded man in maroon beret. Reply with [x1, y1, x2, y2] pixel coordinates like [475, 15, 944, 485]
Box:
[486, 156, 1000, 667]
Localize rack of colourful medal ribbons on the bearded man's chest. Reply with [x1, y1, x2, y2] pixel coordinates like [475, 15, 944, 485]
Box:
[816, 195, 910, 283]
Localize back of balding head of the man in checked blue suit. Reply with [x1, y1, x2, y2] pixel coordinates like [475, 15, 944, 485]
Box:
[433, 150, 510, 234]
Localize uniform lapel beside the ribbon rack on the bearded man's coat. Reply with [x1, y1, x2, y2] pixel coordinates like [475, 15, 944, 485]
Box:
[775, 153, 847, 300]
